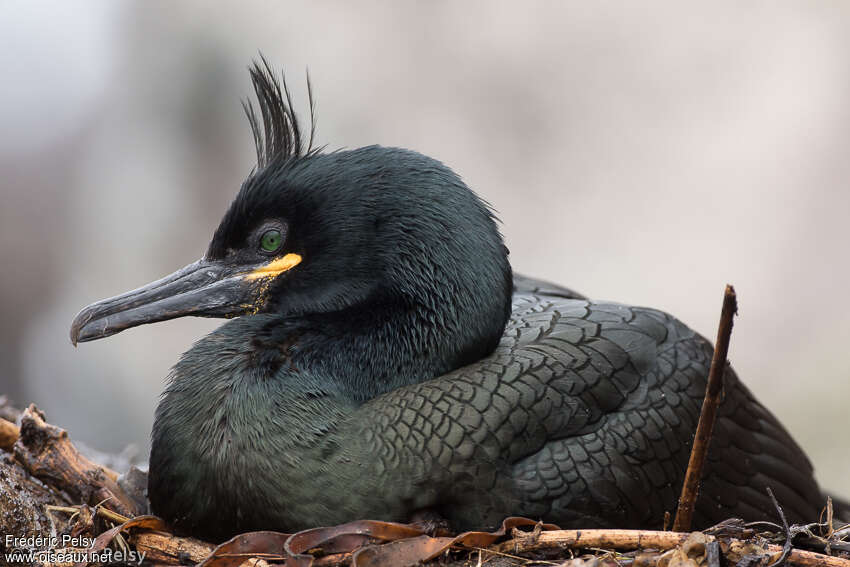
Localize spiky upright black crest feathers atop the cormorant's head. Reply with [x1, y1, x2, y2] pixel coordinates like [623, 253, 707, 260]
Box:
[242, 55, 318, 169]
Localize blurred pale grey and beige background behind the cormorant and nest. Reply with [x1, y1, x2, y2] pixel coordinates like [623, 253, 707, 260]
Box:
[0, 0, 850, 497]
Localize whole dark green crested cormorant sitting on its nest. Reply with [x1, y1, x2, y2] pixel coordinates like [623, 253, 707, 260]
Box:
[71, 61, 821, 539]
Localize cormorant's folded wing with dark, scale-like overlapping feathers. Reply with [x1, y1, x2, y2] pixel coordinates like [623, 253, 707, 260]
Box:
[346, 293, 820, 529]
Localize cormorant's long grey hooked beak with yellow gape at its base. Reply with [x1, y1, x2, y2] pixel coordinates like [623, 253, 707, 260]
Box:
[71, 254, 301, 346]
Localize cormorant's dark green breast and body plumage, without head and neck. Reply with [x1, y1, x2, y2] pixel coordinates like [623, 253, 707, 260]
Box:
[146, 284, 820, 538]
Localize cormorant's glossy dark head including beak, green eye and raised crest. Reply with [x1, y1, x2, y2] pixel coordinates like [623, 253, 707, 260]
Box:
[71, 60, 511, 368]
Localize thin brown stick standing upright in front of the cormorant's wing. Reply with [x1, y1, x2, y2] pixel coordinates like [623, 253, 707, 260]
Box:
[673, 284, 738, 532]
